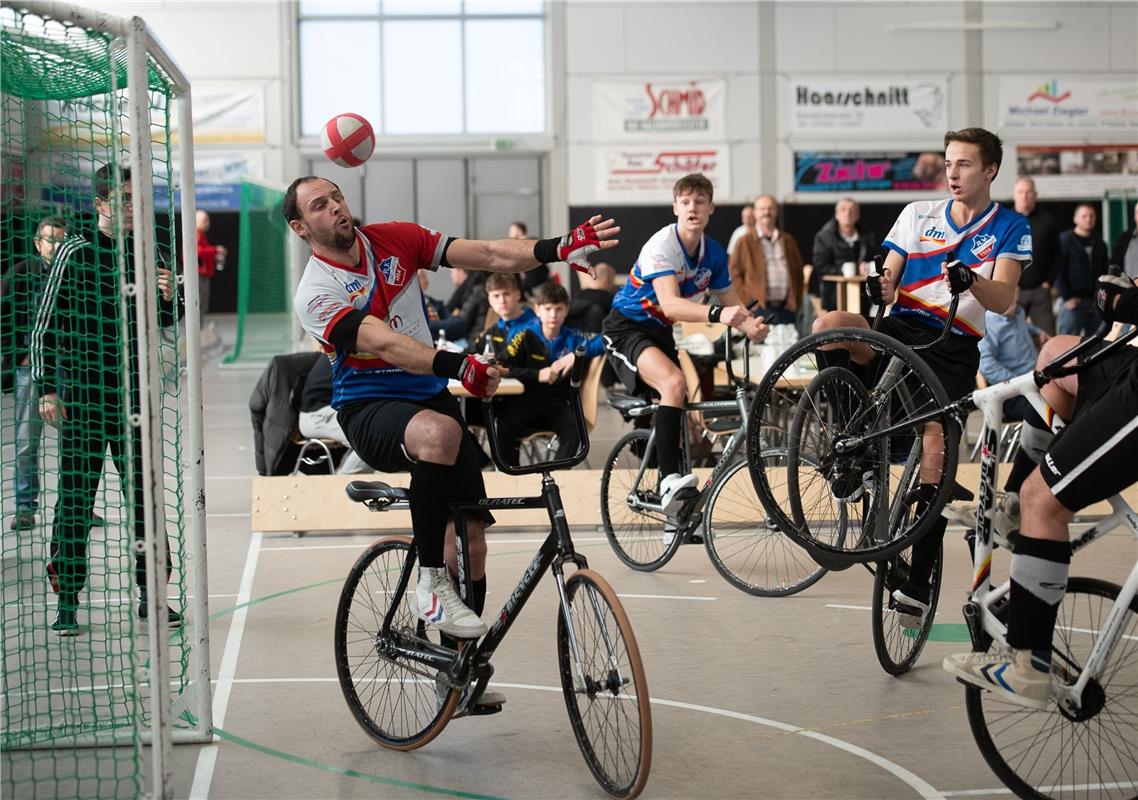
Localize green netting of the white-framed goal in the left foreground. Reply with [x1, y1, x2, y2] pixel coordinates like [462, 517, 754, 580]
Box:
[0, 8, 190, 798]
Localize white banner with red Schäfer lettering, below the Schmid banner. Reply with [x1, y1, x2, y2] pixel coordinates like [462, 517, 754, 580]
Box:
[595, 145, 731, 204]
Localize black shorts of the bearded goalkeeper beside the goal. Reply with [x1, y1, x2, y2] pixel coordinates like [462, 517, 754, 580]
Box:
[337, 389, 494, 525]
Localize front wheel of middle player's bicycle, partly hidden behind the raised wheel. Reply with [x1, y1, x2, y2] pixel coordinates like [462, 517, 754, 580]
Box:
[703, 447, 826, 597]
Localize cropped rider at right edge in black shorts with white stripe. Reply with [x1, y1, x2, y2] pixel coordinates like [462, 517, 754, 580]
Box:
[945, 275, 1138, 709]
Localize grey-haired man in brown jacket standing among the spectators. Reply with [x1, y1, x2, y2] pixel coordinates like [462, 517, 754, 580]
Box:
[728, 195, 805, 325]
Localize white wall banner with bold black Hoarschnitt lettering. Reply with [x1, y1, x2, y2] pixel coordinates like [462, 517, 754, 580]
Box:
[787, 77, 948, 135]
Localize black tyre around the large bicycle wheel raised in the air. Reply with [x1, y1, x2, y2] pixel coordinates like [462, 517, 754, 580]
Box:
[747, 328, 960, 568]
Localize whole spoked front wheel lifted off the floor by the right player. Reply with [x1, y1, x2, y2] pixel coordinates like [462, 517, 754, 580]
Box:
[747, 328, 960, 568]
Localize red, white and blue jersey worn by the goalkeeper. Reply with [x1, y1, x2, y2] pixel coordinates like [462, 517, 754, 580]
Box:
[292, 222, 447, 409]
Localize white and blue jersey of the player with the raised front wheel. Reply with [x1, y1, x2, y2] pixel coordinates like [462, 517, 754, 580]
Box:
[884, 199, 1031, 338]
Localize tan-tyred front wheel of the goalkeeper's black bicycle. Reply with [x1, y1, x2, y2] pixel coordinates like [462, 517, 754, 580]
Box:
[558, 569, 652, 798]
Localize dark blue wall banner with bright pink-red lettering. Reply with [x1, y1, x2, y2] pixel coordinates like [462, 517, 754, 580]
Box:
[794, 151, 947, 191]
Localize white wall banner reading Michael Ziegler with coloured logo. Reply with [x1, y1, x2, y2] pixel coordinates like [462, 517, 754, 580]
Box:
[999, 77, 1138, 133]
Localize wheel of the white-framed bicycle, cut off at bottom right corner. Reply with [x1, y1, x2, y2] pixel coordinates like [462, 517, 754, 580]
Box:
[964, 578, 1138, 800]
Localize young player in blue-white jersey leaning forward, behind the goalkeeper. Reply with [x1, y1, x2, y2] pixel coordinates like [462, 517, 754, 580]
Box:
[602, 173, 767, 512]
